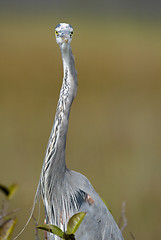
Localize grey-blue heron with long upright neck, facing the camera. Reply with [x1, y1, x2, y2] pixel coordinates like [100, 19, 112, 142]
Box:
[37, 23, 123, 240]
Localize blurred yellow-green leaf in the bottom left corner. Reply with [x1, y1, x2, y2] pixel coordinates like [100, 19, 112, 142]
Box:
[0, 218, 17, 240]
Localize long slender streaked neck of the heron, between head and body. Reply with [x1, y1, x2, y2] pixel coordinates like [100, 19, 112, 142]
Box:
[45, 45, 77, 173]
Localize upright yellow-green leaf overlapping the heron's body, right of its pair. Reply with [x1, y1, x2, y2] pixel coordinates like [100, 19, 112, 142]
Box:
[67, 212, 86, 235]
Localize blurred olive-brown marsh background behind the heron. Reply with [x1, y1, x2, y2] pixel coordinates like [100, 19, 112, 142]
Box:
[0, 0, 161, 240]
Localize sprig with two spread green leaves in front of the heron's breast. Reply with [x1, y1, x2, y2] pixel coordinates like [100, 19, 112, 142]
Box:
[37, 212, 86, 240]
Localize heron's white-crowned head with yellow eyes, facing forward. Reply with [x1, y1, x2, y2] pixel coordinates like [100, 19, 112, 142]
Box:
[55, 23, 73, 48]
